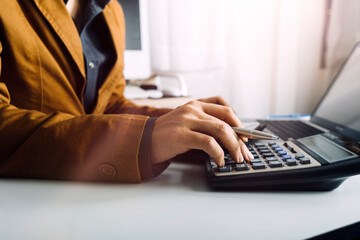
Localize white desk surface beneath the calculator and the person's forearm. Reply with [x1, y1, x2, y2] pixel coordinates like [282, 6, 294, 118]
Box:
[0, 163, 360, 240]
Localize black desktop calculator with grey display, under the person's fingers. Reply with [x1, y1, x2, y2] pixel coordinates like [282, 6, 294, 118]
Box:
[206, 134, 360, 191]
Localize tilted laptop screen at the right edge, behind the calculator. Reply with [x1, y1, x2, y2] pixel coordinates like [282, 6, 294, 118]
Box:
[312, 44, 360, 141]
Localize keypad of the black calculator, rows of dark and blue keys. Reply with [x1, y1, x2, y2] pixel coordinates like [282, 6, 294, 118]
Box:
[211, 142, 321, 176]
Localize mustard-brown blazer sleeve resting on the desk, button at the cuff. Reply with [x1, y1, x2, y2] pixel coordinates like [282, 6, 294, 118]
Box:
[0, 38, 148, 182]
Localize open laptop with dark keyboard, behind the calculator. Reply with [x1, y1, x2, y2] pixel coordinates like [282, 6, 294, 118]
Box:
[258, 43, 360, 143]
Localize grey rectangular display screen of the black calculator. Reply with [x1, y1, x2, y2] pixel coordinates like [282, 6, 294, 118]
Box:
[298, 135, 357, 163]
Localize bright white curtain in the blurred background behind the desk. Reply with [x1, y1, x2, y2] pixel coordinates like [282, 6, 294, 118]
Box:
[148, 0, 325, 118]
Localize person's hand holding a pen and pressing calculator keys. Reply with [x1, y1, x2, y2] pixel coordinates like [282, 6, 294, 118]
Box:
[151, 97, 253, 166]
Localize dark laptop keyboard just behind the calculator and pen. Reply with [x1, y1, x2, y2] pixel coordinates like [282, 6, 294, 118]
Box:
[258, 120, 323, 140]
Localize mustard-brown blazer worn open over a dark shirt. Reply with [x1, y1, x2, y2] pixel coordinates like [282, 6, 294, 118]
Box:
[0, 0, 168, 182]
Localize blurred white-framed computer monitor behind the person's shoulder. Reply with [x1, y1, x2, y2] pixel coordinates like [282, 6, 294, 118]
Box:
[118, 0, 151, 80]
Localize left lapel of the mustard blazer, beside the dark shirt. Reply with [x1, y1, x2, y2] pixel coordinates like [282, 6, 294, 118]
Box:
[34, 0, 85, 79]
